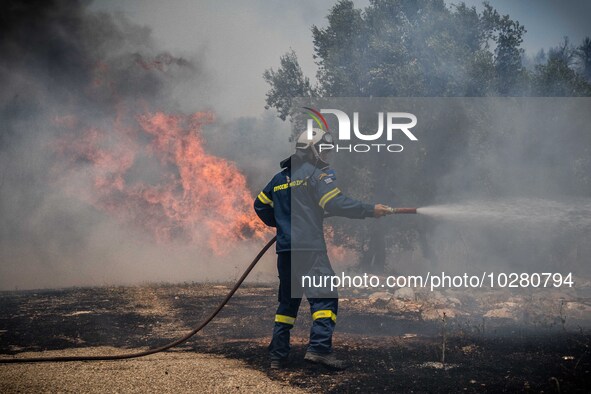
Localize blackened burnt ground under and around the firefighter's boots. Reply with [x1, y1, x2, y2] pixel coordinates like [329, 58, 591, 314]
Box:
[0, 284, 591, 393]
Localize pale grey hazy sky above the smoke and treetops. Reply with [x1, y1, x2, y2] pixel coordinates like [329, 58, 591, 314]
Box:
[92, 0, 591, 116]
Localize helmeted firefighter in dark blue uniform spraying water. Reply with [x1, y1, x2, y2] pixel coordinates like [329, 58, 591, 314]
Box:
[254, 129, 392, 369]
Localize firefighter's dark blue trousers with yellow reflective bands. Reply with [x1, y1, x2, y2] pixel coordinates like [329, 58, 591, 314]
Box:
[269, 252, 338, 360]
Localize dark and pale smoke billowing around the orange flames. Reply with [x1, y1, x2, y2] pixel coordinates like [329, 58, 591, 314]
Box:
[0, 1, 278, 289]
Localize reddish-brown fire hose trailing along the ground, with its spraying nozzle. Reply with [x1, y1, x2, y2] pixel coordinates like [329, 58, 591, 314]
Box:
[0, 208, 417, 364]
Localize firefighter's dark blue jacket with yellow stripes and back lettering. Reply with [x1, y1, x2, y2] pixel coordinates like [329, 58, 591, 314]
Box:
[254, 155, 374, 253]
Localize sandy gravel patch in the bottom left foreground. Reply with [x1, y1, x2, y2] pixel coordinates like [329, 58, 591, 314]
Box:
[0, 347, 303, 393]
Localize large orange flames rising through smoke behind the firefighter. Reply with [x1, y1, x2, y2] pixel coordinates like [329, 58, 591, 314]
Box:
[56, 112, 270, 253]
